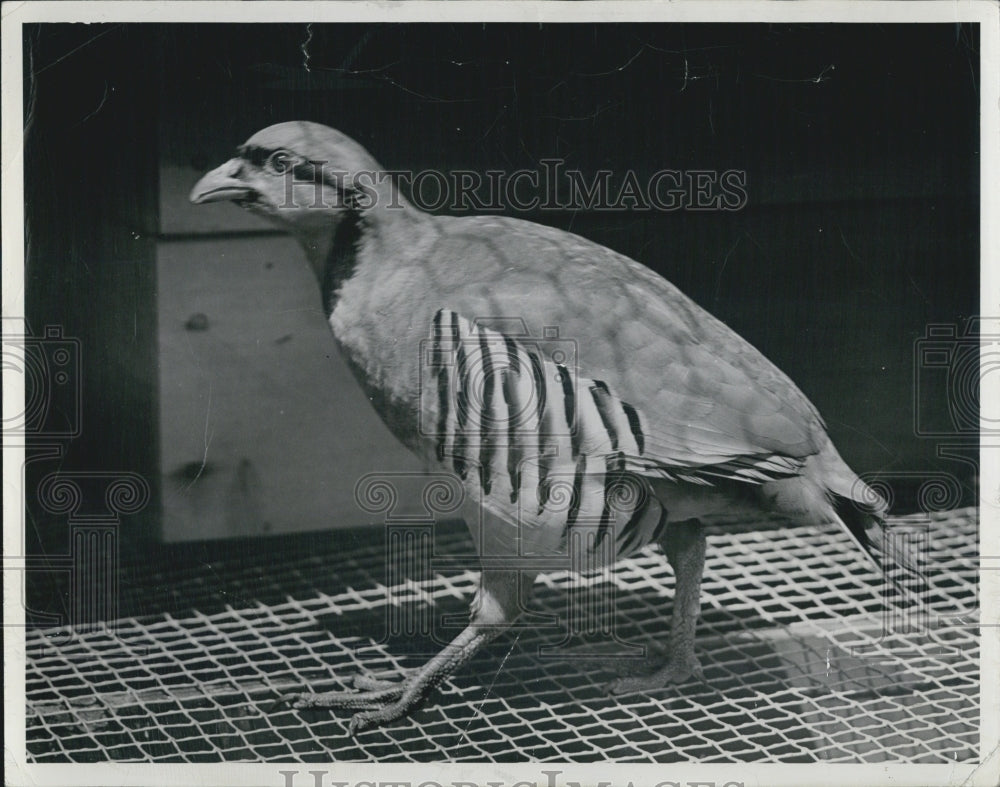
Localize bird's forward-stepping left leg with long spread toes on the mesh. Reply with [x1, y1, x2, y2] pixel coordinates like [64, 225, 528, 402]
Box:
[282, 571, 534, 734]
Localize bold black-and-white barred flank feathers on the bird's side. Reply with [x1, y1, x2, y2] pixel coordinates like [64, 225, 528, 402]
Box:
[424, 309, 802, 558]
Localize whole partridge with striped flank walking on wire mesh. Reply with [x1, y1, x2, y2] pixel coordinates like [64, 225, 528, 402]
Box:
[190, 121, 915, 734]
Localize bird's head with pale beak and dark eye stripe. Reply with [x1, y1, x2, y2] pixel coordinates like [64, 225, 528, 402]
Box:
[190, 121, 405, 240]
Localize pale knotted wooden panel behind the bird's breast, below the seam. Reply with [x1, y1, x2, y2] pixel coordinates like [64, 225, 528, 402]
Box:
[158, 229, 418, 541]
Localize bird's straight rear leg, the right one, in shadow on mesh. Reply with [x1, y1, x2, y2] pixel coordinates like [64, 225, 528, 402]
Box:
[609, 519, 705, 694]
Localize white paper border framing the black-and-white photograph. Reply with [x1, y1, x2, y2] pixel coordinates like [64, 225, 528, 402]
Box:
[0, 0, 1000, 787]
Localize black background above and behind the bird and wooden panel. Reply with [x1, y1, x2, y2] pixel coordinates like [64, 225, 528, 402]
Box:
[25, 24, 979, 620]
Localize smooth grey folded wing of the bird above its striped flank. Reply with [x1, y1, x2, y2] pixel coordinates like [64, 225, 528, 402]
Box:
[414, 212, 826, 477]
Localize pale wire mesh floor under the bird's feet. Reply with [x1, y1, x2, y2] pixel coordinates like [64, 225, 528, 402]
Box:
[26, 509, 979, 763]
